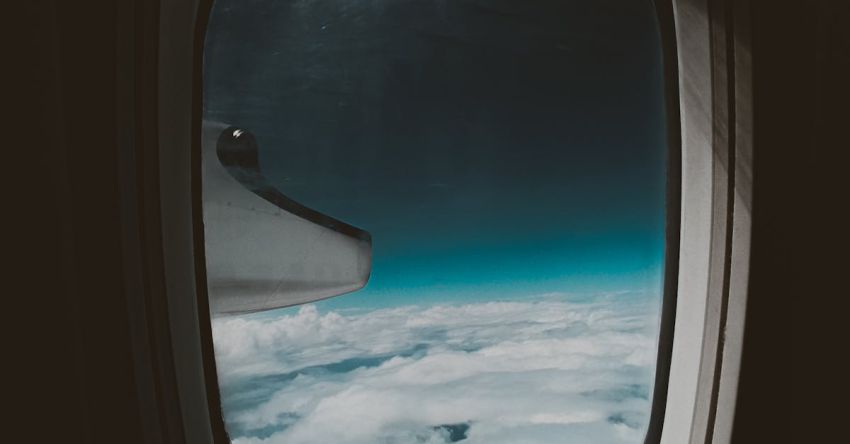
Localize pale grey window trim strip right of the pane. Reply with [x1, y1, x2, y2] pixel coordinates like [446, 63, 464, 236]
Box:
[661, 0, 752, 444]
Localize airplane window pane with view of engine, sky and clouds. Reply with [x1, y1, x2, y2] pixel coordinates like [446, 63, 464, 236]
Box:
[204, 0, 667, 444]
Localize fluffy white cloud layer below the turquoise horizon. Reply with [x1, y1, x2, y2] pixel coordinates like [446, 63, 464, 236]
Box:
[213, 299, 657, 444]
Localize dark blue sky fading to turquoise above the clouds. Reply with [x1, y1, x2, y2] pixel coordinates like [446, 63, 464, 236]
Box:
[205, 0, 666, 306]
